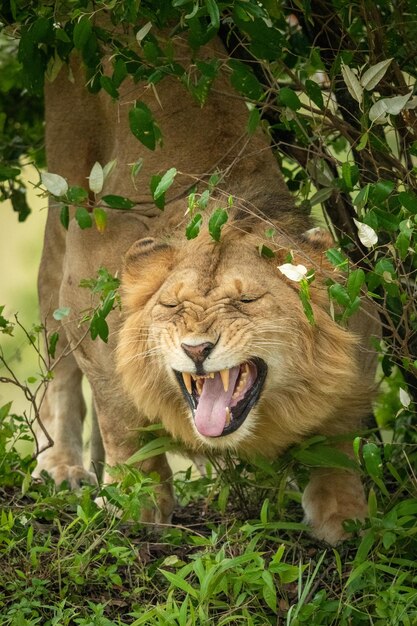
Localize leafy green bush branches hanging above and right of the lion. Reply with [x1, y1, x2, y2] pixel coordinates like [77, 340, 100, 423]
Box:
[0, 0, 417, 398]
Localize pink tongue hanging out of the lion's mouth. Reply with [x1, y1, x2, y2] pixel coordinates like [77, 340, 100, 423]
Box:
[194, 366, 240, 437]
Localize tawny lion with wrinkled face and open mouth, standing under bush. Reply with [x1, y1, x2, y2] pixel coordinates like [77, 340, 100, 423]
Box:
[35, 25, 377, 544]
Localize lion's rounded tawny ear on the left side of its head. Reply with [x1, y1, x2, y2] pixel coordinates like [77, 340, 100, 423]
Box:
[122, 237, 175, 310]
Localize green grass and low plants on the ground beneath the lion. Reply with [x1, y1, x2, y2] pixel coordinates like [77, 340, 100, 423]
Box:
[0, 398, 417, 626]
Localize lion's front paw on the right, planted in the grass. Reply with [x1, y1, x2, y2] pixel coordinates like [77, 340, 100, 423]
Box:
[302, 468, 368, 545]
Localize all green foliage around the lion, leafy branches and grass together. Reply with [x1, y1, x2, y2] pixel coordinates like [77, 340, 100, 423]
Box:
[0, 0, 417, 626]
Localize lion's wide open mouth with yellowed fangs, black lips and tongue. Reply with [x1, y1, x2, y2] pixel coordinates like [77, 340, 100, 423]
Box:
[174, 358, 268, 437]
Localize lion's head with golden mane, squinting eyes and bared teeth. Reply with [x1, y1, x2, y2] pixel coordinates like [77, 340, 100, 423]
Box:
[118, 217, 371, 455]
